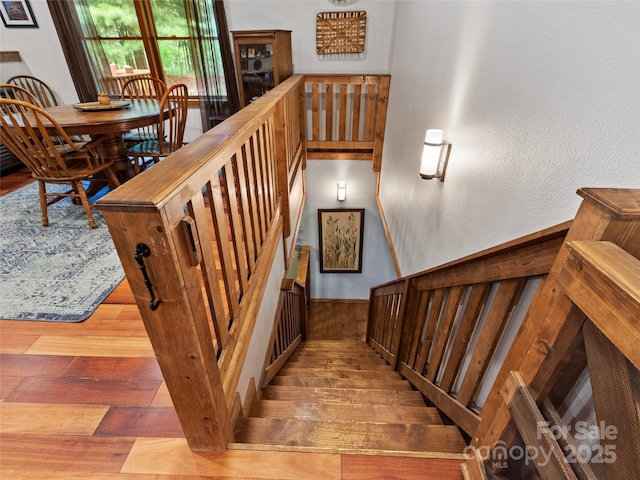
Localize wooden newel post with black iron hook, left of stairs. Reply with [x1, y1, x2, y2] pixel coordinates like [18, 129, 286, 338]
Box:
[98, 204, 233, 451]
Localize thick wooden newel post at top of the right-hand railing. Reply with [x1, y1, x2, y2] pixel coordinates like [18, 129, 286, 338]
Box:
[472, 188, 640, 446]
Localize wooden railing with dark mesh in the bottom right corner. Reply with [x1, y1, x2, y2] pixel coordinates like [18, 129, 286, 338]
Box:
[463, 241, 640, 480]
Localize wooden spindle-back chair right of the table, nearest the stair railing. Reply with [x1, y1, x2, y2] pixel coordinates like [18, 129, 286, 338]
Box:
[127, 83, 189, 174]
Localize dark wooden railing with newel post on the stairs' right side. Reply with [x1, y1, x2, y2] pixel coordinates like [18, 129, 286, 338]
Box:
[367, 189, 640, 445]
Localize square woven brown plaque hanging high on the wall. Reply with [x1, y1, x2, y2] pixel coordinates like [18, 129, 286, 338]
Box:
[316, 10, 367, 55]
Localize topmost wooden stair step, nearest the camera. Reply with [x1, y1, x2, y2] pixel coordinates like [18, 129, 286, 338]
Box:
[235, 417, 466, 453]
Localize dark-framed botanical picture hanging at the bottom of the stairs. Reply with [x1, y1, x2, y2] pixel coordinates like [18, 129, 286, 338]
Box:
[318, 208, 364, 273]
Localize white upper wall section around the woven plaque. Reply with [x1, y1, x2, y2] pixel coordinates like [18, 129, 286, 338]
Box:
[224, 0, 395, 73]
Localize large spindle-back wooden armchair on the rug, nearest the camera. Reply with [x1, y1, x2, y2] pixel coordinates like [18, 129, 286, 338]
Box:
[0, 98, 120, 228]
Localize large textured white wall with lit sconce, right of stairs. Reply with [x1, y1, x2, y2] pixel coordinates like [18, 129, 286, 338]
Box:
[381, 0, 640, 275]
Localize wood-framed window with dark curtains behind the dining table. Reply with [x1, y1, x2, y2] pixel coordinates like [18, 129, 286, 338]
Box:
[48, 0, 239, 130]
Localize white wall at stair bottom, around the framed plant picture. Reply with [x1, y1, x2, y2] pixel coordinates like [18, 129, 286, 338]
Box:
[297, 160, 396, 299]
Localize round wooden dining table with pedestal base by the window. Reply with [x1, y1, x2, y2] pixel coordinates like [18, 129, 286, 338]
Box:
[44, 99, 160, 182]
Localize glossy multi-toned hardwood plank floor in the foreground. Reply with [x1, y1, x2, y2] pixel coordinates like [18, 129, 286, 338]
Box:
[0, 170, 462, 480]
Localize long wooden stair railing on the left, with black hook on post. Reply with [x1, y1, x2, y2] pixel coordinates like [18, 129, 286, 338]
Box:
[97, 75, 304, 451]
